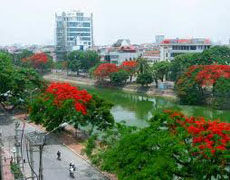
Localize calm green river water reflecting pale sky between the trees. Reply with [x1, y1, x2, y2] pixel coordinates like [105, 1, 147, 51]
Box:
[77, 85, 230, 127]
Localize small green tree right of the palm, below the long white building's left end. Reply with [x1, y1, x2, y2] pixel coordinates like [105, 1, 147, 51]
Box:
[152, 61, 171, 82]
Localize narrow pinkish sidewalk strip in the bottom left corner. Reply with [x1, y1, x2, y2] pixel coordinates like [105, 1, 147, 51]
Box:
[2, 149, 14, 180]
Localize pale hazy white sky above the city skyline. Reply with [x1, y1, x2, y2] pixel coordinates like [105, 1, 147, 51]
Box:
[0, 0, 230, 45]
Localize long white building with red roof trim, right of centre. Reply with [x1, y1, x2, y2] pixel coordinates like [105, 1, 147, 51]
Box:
[160, 39, 212, 61]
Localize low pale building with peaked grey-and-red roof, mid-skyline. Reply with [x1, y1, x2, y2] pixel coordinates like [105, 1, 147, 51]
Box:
[100, 39, 140, 65]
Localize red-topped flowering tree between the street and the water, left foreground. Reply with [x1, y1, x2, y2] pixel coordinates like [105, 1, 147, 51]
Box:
[30, 83, 113, 130]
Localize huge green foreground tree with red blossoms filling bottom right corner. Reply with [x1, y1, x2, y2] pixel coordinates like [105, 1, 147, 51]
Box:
[87, 110, 230, 180]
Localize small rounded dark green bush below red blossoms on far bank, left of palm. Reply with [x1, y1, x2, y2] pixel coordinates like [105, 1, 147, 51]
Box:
[109, 70, 129, 85]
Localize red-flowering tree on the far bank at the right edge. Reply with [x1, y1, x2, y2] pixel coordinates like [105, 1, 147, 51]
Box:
[176, 65, 230, 107]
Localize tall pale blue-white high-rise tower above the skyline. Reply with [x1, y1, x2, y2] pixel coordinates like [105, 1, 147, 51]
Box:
[55, 11, 94, 59]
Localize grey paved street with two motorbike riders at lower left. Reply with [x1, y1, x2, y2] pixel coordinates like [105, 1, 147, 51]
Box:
[0, 109, 105, 180]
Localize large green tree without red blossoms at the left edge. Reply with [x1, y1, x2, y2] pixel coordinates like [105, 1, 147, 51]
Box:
[0, 54, 43, 110]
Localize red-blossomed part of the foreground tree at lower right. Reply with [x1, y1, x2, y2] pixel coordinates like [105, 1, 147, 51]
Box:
[165, 110, 230, 156]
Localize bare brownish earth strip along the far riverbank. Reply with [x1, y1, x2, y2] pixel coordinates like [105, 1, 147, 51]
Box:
[43, 72, 176, 99]
